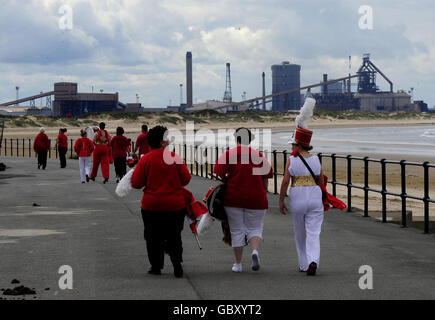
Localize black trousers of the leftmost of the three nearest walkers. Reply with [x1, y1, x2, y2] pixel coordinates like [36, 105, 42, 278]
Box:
[142, 209, 187, 270]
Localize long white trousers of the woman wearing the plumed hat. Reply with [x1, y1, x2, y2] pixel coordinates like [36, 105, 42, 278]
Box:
[289, 186, 324, 271]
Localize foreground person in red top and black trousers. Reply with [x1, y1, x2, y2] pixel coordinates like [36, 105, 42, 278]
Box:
[131, 126, 192, 278]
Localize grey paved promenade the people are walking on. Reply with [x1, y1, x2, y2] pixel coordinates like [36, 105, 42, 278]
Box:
[0, 157, 435, 300]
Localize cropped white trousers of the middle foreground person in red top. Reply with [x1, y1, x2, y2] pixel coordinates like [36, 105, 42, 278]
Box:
[225, 207, 267, 247]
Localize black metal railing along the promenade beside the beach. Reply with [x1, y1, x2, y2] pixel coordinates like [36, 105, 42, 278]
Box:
[0, 139, 435, 233]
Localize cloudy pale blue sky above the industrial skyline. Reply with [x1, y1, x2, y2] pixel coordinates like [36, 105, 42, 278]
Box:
[0, 0, 435, 107]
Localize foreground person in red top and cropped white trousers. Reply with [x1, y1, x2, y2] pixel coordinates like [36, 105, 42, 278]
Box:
[214, 128, 273, 272]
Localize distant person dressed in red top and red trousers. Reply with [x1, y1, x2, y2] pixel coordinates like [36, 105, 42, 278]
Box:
[89, 122, 110, 183]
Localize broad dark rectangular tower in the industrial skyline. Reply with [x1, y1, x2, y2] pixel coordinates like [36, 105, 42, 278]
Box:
[272, 61, 301, 111]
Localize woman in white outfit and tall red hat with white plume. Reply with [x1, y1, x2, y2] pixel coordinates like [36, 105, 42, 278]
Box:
[279, 98, 324, 276]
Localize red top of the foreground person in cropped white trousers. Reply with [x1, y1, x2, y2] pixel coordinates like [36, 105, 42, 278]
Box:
[214, 146, 273, 210]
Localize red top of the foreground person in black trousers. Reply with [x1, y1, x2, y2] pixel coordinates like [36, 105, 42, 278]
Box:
[131, 149, 192, 212]
